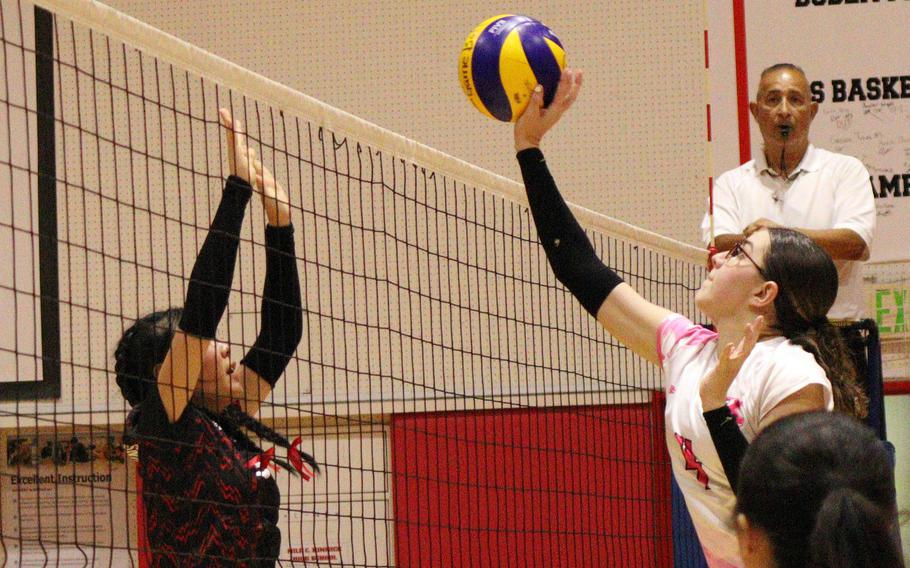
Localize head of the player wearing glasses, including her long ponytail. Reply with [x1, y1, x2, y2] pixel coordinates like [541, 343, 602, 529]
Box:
[695, 228, 867, 417]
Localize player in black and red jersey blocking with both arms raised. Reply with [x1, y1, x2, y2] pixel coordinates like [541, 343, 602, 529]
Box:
[115, 109, 316, 566]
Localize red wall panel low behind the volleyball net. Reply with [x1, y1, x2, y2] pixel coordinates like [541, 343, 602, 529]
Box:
[391, 401, 672, 567]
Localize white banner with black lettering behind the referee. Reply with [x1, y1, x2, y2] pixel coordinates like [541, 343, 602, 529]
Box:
[715, 0, 910, 262]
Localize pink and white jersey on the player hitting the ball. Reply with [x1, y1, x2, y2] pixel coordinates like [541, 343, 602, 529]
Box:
[657, 314, 834, 568]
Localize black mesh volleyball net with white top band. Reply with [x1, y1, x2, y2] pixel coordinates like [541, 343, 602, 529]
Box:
[0, 0, 705, 566]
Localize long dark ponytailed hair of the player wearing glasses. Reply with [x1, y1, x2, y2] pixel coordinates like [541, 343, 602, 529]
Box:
[764, 228, 869, 418]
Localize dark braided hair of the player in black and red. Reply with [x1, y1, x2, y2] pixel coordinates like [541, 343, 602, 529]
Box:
[114, 308, 319, 474]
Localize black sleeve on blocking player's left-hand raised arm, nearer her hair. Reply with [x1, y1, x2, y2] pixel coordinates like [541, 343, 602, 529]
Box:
[180, 176, 253, 339]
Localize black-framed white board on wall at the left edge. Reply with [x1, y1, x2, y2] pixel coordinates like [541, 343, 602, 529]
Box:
[0, 7, 60, 400]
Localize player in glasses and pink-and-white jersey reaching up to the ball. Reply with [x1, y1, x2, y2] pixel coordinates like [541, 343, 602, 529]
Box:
[515, 70, 864, 567]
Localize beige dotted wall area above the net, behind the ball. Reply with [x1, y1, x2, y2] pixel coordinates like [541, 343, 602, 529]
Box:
[100, 0, 707, 244]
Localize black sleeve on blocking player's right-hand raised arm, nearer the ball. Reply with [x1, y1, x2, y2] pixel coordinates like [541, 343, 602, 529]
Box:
[242, 225, 303, 387]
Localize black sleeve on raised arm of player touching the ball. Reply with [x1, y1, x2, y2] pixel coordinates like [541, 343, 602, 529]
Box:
[517, 148, 622, 317]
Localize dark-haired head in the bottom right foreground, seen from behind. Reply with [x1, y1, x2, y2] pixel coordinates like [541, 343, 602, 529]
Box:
[735, 412, 904, 568]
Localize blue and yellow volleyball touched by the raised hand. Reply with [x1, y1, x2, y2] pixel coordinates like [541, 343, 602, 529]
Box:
[458, 14, 566, 122]
